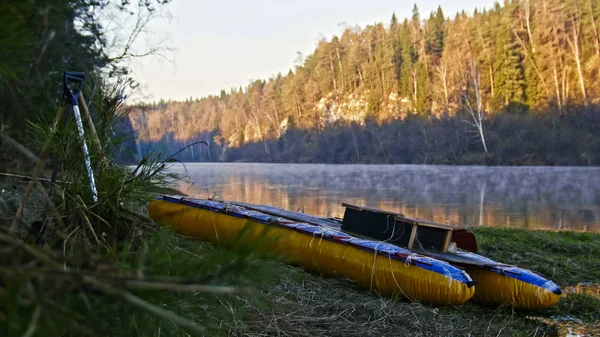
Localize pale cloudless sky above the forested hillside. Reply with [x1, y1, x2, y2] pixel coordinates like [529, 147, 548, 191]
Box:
[133, 0, 495, 101]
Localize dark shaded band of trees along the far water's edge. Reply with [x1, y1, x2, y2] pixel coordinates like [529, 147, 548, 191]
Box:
[227, 108, 600, 166]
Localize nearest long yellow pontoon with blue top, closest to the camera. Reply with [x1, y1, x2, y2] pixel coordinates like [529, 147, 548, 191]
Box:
[148, 196, 475, 305]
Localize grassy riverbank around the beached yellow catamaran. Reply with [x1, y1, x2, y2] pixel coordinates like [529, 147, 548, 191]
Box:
[0, 215, 600, 336]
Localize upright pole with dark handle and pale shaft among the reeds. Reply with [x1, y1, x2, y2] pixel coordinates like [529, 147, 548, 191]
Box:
[64, 71, 98, 202]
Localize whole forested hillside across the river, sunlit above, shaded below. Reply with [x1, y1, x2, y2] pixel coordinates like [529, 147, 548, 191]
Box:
[130, 0, 600, 165]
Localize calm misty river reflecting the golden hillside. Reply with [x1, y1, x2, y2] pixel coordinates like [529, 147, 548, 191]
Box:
[165, 163, 600, 232]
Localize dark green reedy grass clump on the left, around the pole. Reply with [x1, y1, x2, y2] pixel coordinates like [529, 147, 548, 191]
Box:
[0, 78, 216, 336]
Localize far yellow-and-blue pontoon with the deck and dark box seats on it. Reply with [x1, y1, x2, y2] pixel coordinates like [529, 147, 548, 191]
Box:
[229, 198, 561, 310]
